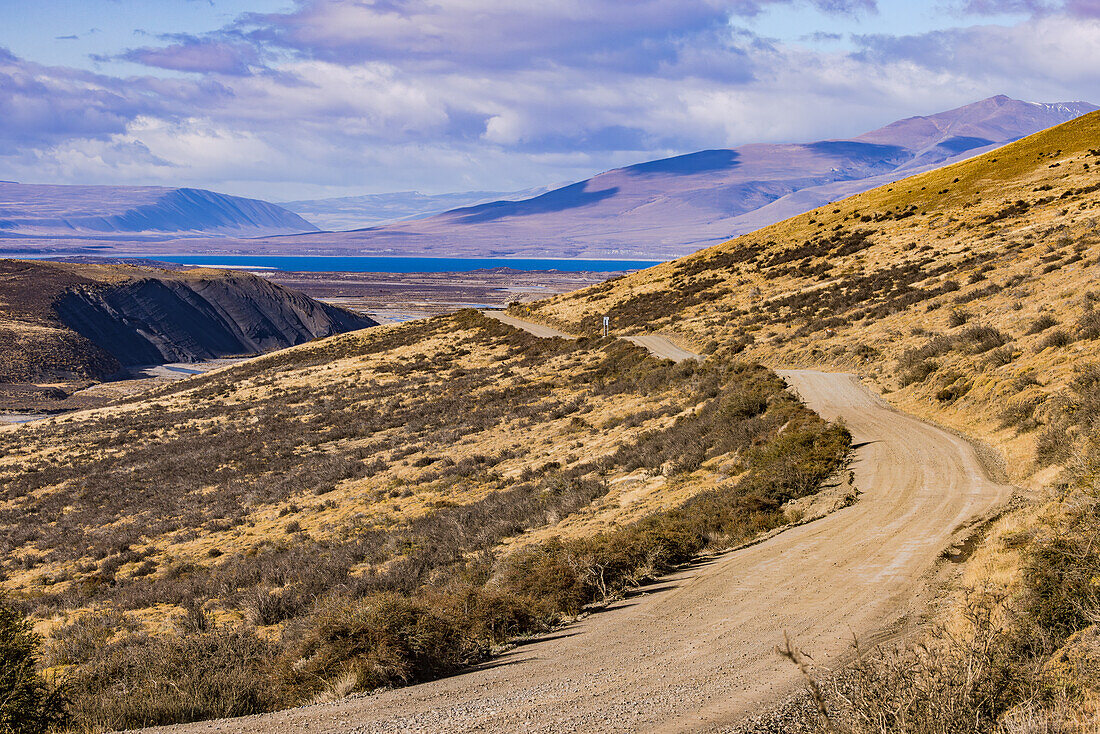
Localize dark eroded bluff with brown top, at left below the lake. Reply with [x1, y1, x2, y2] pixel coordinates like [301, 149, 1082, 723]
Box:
[0, 260, 377, 383]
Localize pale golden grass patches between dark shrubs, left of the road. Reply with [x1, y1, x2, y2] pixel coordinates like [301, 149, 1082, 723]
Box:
[0, 312, 707, 631]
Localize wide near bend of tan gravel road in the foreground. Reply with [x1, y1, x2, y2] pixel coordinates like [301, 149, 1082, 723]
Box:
[139, 363, 1010, 734]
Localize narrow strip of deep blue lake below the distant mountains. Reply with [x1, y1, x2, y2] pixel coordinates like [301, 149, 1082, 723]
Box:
[141, 254, 661, 273]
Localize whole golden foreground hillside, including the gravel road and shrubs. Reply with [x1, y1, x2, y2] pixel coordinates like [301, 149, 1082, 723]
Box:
[0, 103, 1100, 734]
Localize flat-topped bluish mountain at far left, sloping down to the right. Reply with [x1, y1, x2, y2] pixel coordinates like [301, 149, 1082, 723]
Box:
[0, 182, 318, 237]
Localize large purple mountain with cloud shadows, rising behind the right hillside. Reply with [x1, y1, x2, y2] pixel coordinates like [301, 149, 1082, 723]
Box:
[159, 96, 1098, 259]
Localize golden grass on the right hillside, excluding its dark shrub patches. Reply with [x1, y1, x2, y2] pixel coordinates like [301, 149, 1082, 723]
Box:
[528, 113, 1100, 481]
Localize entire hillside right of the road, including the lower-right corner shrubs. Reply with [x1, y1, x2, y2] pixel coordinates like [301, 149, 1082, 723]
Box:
[517, 113, 1100, 733]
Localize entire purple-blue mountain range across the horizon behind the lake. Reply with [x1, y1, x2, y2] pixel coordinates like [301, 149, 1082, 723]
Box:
[0, 96, 1098, 260]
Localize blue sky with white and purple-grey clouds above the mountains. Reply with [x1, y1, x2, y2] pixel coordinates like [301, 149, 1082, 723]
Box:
[0, 0, 1100, 200]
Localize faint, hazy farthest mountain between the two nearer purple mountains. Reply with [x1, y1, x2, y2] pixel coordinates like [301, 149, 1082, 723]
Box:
[279, 186, 552, 231]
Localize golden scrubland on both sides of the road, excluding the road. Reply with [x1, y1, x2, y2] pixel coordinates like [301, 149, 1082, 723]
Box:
[8, 101, 1100, 734]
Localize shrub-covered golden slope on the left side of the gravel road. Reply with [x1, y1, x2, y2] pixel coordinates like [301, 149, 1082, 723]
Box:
[0, 311, 848, 728]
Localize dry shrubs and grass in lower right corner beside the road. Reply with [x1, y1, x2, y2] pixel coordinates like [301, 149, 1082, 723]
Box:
[796, 385, 1100, 734]
